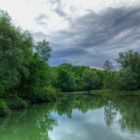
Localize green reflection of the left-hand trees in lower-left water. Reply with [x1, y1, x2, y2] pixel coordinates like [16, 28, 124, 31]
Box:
[0, 105, 57, 140]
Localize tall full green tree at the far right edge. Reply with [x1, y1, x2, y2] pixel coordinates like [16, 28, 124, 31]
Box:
[117, 50, 140, 90]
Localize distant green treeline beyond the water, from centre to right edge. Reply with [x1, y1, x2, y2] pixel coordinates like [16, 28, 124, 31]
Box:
[51, 51, 140, 91]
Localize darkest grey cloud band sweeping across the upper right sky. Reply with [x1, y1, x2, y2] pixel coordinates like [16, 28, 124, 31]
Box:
[68, 8, 140, 47]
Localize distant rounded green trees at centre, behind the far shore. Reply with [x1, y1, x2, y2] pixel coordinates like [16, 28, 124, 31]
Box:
[53, 64, 104, 91]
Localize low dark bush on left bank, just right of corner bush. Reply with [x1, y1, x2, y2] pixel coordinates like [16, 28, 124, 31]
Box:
[5, 96, 28, 109]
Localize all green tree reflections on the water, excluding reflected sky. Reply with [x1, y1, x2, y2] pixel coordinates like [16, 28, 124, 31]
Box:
[0, 94, 140, 140]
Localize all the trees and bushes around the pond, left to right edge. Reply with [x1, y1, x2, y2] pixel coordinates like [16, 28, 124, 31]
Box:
[0, 10, 140, 116]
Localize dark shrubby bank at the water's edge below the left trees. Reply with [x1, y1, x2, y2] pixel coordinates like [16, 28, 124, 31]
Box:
[0, 93, 60, 117]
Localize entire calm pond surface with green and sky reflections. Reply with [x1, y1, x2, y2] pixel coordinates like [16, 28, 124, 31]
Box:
[0, 94, 140, 140]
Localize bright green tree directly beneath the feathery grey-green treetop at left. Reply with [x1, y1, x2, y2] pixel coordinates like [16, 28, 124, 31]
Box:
[25, 54, 49, 93]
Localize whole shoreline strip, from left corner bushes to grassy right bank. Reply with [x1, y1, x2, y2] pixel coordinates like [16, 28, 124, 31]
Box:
[0, 89, 140, 117]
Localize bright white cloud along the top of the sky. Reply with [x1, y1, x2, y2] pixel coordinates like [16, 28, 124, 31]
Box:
[0, 0, 138, 32]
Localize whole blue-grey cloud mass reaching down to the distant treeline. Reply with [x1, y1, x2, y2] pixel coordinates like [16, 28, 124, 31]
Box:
[32, 7, 140, 66]
